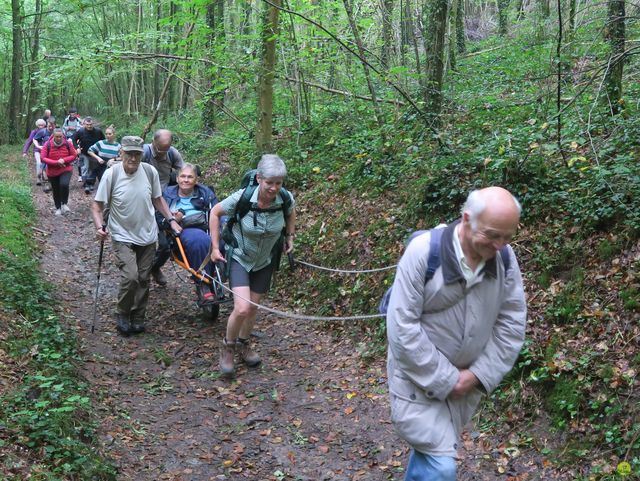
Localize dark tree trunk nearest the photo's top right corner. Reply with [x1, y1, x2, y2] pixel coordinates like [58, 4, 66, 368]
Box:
[605, 0, 625, 115]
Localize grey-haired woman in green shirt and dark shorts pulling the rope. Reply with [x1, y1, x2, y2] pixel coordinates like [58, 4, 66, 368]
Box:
[209, 155, 296, 377]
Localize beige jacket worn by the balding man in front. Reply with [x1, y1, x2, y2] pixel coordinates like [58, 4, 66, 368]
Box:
[387, 222, 526, 456]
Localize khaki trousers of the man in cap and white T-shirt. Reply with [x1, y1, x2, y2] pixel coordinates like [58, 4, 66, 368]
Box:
[112, 240, 156, 320]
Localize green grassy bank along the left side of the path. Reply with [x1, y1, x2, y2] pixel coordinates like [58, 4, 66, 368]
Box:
[0, 147, 115, 481]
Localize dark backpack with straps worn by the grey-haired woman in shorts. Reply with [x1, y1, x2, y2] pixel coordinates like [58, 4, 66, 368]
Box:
[222, 169, 293, 270]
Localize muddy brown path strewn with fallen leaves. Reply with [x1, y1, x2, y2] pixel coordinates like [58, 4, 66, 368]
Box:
[33, 163, 559, 481]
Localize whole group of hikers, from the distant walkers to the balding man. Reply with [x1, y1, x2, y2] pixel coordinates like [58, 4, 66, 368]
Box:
[22, 109, 526, 481]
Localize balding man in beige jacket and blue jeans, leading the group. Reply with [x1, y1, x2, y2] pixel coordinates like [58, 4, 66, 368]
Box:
[387, 187, 527, 481]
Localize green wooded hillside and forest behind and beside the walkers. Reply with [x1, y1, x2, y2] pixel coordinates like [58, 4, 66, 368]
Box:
[0, 0, 640, 480]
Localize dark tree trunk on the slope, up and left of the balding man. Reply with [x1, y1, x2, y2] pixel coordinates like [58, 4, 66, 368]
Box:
[424, 0, 449, 119]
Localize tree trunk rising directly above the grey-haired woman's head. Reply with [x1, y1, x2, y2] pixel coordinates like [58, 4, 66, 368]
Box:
[256, 0, 282, 154]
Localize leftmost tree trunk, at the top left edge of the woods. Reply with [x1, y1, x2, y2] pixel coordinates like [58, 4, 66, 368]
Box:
[6, 0, 22, 141]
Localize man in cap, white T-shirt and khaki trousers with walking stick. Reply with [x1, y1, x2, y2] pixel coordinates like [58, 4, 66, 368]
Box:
[92, 136, 182, 336]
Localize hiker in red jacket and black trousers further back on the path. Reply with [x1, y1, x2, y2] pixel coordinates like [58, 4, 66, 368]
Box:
[41, 128, 78, 215]
